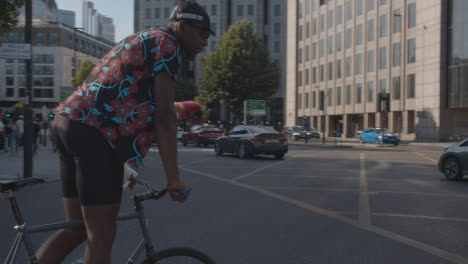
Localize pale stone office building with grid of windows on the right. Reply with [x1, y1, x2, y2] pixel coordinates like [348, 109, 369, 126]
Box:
[286, 0, 468, 140]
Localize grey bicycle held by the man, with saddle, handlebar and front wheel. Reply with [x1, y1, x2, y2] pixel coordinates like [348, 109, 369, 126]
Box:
[0, 177, 215, 264]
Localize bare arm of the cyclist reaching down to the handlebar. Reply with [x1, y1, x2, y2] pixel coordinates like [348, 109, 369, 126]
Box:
[153, 72, 187, 201]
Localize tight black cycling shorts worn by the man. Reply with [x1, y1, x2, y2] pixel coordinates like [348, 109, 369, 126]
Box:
[51, 113, 124, 206]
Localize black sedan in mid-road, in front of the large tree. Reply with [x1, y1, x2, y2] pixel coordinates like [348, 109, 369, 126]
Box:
[214, 125, 288, 159]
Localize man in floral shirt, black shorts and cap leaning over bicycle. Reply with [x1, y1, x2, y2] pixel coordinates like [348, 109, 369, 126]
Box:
[37, 1, 214, 264]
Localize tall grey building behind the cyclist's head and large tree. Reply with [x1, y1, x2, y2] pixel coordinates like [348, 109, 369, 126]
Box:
[134, 0, 287, 126]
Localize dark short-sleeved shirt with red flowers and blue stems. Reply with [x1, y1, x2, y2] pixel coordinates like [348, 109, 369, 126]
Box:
[56, 29, 181, 166]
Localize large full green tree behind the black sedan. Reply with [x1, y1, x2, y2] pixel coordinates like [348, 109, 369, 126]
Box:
[200, 20, 280, 120]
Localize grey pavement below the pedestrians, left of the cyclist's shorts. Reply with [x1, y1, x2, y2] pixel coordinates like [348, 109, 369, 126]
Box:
[0, 143, 60, 181]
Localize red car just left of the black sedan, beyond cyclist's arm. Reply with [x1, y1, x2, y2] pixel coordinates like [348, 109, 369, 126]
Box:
[182, 125, 224, 147]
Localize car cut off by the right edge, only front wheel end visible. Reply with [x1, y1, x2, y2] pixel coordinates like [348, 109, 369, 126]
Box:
[438, 138, 468, 180]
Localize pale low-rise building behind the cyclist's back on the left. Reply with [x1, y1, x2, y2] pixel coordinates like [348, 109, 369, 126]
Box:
[0, 20, 114, 112]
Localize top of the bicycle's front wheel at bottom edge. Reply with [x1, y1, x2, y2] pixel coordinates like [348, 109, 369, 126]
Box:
[143, 248, 216, 264]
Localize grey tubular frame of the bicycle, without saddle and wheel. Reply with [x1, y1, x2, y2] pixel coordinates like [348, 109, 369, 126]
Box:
[0, 179, 161, 264]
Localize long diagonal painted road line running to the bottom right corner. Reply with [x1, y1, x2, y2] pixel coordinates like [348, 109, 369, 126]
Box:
[181, 168, 468, 264]
